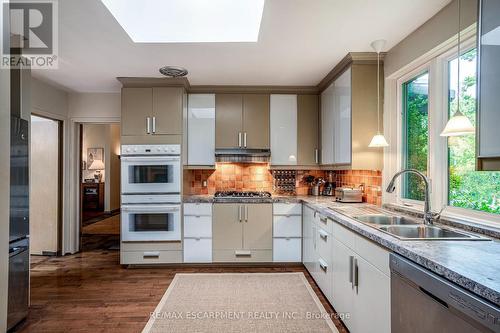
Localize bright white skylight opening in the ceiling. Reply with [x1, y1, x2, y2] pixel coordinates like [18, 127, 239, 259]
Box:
[101, 0, 265, 43]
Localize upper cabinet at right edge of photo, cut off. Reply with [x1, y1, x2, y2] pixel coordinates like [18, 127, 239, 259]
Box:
[477, 0, 500, 171]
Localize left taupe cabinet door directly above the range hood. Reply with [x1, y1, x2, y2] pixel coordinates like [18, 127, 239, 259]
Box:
[215, 94, 243, 148]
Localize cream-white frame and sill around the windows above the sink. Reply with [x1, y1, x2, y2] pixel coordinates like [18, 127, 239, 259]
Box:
[382, 25, 500, 229]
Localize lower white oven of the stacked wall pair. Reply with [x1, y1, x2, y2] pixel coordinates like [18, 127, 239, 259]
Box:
[121, 203, 181, 242]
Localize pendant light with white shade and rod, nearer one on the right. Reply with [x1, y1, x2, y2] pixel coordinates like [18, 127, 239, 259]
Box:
[441, 0, 476, 137]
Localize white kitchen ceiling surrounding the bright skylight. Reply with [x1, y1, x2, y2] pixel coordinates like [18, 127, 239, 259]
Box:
[33, 0, 450, 92]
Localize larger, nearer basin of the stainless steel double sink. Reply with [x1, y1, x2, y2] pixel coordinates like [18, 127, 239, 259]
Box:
[379, 224, 487, 240]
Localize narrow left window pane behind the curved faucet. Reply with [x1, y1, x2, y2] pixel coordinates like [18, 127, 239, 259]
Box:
[403, 72, 429, 200]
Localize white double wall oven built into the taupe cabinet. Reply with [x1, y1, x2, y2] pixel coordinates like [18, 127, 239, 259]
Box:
[121, 145, 181, 242]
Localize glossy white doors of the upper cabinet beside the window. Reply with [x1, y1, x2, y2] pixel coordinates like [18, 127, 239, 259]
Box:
[321, 68, 352, 164]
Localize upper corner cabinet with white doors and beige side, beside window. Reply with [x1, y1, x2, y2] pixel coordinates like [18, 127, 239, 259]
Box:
[321, 58, 383, 170]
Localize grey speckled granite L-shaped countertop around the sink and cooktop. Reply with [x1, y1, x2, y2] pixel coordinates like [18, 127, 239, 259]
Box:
[184, 195, 500, 306]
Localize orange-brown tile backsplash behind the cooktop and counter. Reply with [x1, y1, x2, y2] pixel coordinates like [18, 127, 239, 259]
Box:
[184, 163, 382, 206]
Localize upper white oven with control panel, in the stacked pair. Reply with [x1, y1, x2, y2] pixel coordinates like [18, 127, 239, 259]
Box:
[121, 145, 181, 194]
